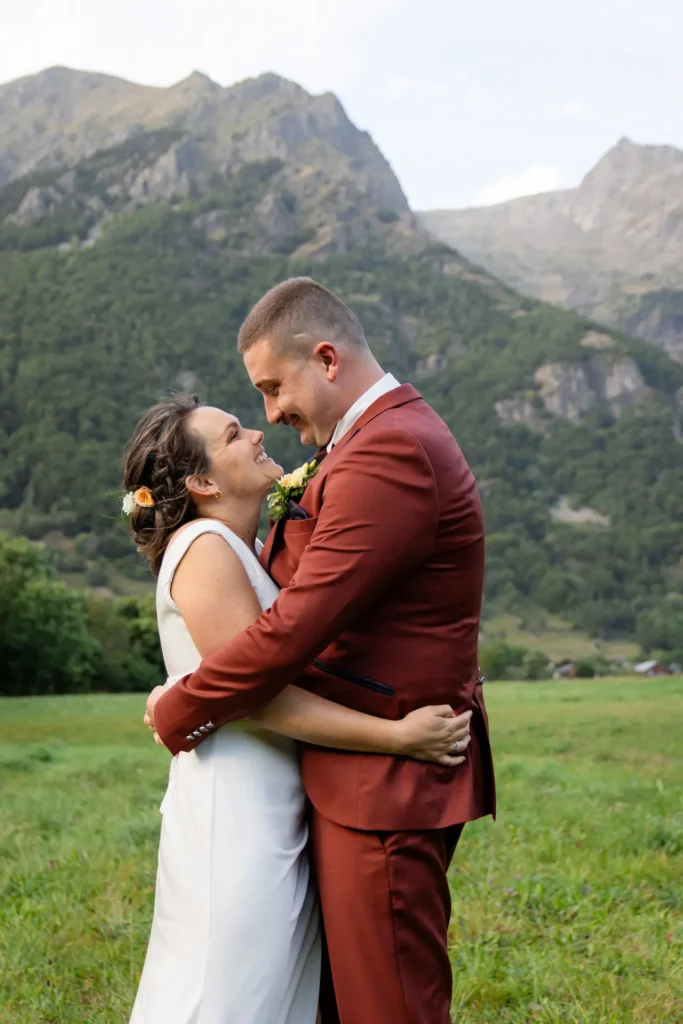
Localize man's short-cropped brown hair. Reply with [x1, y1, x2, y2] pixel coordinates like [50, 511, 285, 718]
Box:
[238, 278, 368, 354]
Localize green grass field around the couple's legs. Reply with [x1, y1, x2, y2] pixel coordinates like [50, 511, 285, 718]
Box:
[0, 679, 683, 1024]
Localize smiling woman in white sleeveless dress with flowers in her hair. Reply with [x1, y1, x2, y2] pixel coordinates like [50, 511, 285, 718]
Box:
[124, 395, 470, 1024]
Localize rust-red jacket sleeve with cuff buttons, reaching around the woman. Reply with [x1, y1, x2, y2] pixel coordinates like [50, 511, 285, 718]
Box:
[155, 429, 438, 754]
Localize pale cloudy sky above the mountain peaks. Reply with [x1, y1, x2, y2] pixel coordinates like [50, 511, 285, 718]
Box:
[0, 0, 683, 210]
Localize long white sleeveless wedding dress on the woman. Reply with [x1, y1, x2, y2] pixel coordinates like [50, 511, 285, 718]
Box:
[130, 519, 321, 1024]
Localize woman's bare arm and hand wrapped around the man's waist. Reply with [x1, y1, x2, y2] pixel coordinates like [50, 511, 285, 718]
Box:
[171, 534, 471, 765]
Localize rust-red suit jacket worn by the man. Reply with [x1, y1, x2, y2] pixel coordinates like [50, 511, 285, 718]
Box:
[156, 384, 495, 831]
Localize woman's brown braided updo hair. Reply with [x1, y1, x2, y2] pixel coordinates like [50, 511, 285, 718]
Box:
[123, 394, 211, 575]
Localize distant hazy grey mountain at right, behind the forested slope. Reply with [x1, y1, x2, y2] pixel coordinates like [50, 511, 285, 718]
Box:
[420, 138, 683, 361]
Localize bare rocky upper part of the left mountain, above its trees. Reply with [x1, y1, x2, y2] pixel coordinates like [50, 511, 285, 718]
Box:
[0, 68, 417, 256]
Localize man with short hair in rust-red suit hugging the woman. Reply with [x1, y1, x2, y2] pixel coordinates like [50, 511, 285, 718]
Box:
[147, 278, 495, 1024]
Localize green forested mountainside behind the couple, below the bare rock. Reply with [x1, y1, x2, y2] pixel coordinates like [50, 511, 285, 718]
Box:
[0, 190, 683, 647]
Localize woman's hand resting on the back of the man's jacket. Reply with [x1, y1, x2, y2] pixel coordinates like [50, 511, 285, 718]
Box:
[396, 705, 472, 768]
